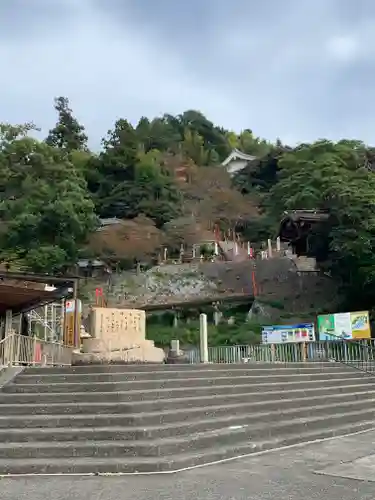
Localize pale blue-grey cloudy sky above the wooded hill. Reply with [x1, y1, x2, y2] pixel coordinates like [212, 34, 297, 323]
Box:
[0, 0, 375, 148]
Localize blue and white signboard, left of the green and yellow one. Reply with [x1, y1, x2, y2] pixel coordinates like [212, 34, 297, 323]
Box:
[262, 323, 315, 344]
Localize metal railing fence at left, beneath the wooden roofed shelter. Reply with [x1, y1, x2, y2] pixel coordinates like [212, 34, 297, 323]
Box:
[0, 333, 73, 366]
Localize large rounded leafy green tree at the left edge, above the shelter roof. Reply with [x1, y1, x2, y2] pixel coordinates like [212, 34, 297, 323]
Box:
[0, 125, 96, 272]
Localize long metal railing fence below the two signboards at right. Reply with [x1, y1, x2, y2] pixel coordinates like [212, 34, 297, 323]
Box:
[188, 339, 375, 366]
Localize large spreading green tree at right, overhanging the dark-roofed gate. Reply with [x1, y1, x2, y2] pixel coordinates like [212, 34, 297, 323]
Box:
[268, 140, 375, 309]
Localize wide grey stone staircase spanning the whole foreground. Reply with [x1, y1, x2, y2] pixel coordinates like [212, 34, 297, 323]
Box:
[0, 363, 375, 475]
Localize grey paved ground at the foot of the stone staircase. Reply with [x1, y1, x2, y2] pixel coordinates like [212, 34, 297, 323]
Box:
[0, 431, 375, 500]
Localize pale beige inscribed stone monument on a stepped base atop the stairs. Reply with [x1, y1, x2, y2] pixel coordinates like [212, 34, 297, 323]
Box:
[76, 307, 165, 363]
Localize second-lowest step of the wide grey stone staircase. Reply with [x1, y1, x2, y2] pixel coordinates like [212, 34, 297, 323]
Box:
[0, 409, 375, 460]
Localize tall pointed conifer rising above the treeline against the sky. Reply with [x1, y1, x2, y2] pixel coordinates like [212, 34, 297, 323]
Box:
[46, 96, 88, 152]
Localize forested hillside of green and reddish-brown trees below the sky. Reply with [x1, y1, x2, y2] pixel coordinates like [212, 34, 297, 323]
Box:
[0, 97, 375, 309]
